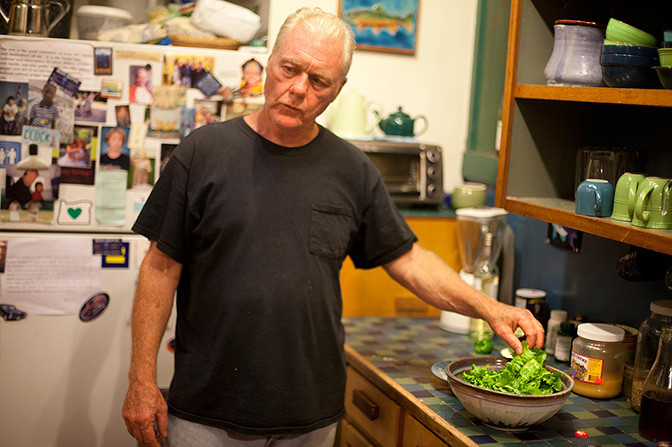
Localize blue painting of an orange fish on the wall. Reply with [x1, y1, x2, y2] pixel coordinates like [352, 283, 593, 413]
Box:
[338, 0, 420, 54]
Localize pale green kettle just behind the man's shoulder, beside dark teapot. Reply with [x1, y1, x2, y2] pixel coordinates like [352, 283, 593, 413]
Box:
[329, 90, 383, 139]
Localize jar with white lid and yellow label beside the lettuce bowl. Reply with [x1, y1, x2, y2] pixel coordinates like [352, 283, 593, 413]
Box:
[571, 323, 626, 399]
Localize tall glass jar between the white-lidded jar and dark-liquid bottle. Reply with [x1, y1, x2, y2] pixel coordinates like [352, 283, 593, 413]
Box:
[630, 300, 672, 412]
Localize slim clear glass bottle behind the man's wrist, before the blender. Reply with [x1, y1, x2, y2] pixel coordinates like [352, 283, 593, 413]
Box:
[469, 233, 499, 340]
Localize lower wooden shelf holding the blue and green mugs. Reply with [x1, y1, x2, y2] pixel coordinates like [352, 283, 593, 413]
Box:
[504, 196, 672, 255]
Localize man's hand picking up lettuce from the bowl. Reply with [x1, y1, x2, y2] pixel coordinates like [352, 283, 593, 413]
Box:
[486, 301, 544, 355]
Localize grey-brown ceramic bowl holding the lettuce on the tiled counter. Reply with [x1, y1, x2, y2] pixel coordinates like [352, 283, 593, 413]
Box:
[446, 357, 574, 431]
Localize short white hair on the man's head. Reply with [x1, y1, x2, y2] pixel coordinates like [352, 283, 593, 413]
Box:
[269, 6, 356, 78]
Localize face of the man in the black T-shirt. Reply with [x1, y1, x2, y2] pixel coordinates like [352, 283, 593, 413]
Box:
[264, 25, 345, 131]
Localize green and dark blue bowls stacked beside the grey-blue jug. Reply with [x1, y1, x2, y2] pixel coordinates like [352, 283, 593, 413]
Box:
[600, 18, 660, 88]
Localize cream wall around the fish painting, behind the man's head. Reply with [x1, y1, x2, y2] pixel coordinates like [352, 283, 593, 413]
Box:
[268, 0, 478, 191]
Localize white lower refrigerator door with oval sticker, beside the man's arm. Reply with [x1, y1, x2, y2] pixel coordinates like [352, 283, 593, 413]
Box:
[0, 233, 175, 447]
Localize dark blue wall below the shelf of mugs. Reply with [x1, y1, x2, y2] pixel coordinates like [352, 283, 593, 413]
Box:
[508, 215, 672, 328]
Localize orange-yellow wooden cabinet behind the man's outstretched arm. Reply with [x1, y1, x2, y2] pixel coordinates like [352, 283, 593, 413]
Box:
[341, 217, 462, 317]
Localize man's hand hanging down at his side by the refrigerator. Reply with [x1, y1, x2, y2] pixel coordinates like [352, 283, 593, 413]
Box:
[122, 382, 168, 447]
